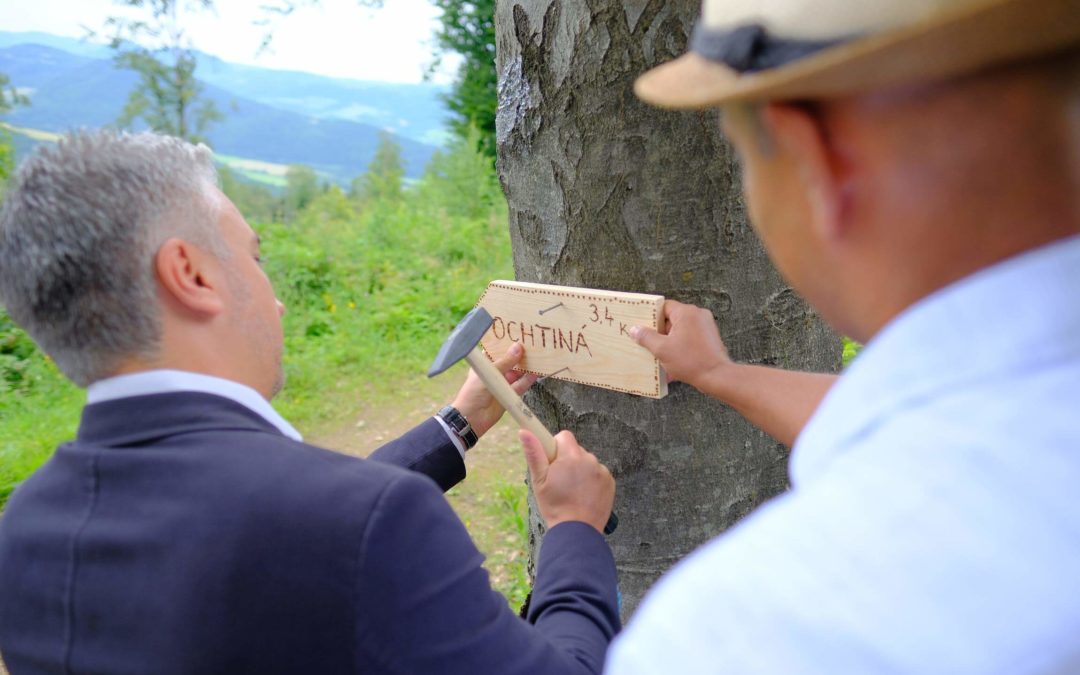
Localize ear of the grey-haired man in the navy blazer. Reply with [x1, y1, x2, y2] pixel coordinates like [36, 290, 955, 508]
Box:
[153, 238, 225, 316]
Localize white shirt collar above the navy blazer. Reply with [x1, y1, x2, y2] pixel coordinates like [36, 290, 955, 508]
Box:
[86, 369, 303, 441]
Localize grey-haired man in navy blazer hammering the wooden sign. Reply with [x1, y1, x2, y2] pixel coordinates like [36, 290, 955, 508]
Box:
[0, 132, 619, 675]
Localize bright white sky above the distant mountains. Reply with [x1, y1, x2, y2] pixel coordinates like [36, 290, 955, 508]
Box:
[0, 0, 459, 83]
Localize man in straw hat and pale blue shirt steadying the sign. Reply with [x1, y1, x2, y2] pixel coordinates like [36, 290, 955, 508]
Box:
[608, 0, 1080, 674]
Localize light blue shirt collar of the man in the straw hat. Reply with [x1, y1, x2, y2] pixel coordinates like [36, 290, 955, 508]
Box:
[791, 237, 1080, 485]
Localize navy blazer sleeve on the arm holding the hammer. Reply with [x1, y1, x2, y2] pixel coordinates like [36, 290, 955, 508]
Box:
[356, 474, 619, 675]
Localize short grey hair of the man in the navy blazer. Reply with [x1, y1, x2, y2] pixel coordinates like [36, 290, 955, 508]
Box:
[0, 131, 227, 387]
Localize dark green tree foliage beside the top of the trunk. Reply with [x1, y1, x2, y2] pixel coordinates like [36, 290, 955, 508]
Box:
[432, 0, 498, 159]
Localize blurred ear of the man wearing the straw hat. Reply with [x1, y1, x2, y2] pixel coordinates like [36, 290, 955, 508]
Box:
[762, 104, 848, 241]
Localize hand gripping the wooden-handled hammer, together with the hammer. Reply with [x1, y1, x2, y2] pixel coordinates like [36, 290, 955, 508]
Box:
[428, 307, 619, 535]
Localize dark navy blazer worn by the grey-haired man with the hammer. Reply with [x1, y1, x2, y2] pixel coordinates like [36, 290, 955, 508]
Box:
[0, 393, 619, 675]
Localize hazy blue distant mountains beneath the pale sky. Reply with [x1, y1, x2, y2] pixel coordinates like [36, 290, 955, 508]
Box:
[0, 31, 446, 183]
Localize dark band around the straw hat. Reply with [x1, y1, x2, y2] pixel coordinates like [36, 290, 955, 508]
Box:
[690, 23, 851, 72]
